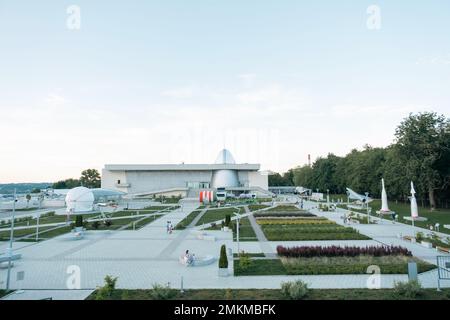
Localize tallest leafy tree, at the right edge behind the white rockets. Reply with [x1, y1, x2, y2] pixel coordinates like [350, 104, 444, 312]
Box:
[395, 112, 450, 210]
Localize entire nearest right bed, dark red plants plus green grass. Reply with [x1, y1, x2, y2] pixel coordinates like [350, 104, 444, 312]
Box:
[234, 246, 436, 276]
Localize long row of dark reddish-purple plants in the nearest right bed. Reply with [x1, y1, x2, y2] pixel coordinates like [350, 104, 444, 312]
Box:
[277, 246, 412, 258]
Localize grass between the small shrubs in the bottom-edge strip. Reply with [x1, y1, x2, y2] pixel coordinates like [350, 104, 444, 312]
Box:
[87, 289, 450, 301]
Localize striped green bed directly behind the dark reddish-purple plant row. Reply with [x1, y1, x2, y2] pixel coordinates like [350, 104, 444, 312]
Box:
[257, 218, 370, 241]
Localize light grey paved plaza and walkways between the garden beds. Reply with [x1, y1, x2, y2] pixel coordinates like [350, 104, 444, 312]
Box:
[0, 198, 450, 299]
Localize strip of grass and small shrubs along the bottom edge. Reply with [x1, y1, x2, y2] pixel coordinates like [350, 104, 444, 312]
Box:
[87, 276, 450, 300]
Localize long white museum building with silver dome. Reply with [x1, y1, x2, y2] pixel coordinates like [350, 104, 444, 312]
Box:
[102, 150, 268, 196]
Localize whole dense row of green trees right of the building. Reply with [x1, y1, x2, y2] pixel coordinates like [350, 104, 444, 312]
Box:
[269, 112, 450, 207]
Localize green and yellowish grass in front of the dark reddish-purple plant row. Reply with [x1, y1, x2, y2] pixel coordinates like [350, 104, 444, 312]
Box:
[234, 256, 436, 276]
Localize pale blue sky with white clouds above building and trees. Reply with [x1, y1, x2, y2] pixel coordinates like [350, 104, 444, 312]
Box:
[0, 0, 450, 183]
